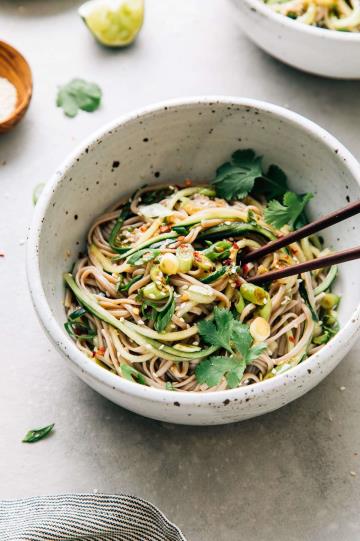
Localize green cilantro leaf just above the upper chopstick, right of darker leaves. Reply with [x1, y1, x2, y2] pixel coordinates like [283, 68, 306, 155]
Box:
[264, 192, 314, 229]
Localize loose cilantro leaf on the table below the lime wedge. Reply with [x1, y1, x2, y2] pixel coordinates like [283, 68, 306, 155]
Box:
[56, 79, 102, 118]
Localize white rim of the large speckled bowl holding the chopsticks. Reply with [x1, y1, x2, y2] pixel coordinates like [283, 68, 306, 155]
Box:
[26, 95, 360, 406]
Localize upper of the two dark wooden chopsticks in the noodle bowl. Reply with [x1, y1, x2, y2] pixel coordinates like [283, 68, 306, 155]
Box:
[241, 200, 360, 268]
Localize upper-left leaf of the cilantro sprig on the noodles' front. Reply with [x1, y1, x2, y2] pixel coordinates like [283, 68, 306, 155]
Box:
[198, 306, 234, 352]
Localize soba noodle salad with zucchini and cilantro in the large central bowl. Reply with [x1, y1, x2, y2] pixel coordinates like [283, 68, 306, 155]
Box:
[64, 149, 340, 391]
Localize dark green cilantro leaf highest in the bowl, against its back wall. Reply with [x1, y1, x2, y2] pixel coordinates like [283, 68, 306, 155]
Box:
[212, 149, 262, 200]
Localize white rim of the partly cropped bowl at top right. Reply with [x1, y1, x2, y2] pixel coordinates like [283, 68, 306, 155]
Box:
[240, 0, 360, 42]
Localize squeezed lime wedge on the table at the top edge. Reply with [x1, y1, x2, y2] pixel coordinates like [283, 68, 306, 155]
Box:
[79, 0, 144, 47]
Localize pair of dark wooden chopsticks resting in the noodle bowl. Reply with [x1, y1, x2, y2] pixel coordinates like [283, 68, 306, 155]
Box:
[245, 200, 360, 284]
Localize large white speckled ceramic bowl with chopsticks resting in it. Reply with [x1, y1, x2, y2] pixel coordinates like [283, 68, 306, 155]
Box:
[27, 97, 360, 425]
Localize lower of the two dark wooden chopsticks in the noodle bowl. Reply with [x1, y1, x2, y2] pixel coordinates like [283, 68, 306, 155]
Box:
[246, 246, 360, 284]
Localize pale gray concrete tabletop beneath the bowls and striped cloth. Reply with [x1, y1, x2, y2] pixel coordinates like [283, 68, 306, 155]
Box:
[0, 0, 360, 541]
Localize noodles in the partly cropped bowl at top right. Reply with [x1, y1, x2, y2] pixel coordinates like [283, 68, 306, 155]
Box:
[264, 0, 360, 32]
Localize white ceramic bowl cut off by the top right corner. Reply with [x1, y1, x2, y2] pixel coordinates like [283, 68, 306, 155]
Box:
[231, 0, 360, 79]
